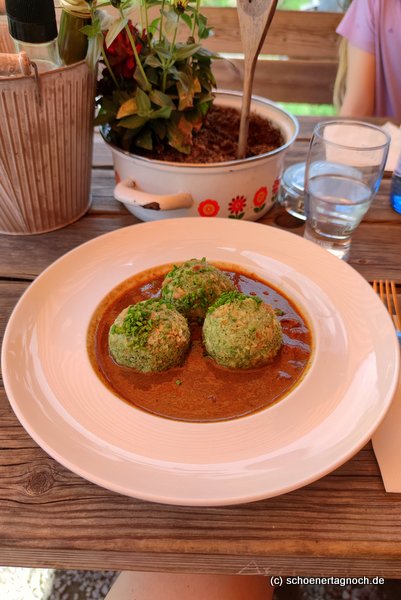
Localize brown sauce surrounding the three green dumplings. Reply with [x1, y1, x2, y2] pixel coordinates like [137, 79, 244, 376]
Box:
[88, 263, 311, 421]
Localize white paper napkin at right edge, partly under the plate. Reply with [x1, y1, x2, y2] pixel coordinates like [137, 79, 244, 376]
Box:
[372, 374, 401, 493]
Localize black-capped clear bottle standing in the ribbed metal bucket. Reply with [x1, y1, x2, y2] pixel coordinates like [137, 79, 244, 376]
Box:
[6, 0, 63, 73]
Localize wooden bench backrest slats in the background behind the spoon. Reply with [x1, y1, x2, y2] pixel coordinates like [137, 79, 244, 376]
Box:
[0, 8, 342, 104]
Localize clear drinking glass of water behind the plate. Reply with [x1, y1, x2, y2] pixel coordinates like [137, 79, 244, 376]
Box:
[304, 120, 390, 260]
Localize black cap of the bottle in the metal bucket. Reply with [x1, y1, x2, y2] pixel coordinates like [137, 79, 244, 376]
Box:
[6, 0, 57, 44]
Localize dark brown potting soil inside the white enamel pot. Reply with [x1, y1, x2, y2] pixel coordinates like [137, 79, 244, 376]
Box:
[136, 105, 284, 163]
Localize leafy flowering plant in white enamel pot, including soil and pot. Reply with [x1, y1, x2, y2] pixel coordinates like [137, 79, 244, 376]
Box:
[83, 0, 298, 220]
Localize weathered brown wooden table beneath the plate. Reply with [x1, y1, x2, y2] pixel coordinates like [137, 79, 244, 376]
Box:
[0, 118, 401, 578]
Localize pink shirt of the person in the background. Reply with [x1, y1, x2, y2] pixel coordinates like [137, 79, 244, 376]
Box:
[337, 0, 401, 120]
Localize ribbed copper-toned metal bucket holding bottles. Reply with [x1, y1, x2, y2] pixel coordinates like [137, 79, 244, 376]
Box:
[0, 22, 95, 235]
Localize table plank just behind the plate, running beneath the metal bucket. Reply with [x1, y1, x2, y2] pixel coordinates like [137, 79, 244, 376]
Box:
[0, 195, 401, 280]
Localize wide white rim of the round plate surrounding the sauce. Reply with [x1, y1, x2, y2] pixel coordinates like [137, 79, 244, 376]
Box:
[2, 218, 399, 506]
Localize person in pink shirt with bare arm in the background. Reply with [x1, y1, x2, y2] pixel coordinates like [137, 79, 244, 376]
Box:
[335, 0, 401, 120]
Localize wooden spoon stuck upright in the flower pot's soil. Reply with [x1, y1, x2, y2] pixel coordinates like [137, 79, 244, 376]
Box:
[237, 0, 277, 158]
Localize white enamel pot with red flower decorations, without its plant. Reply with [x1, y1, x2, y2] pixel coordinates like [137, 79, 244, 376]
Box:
[105, 92, 299, 221]
